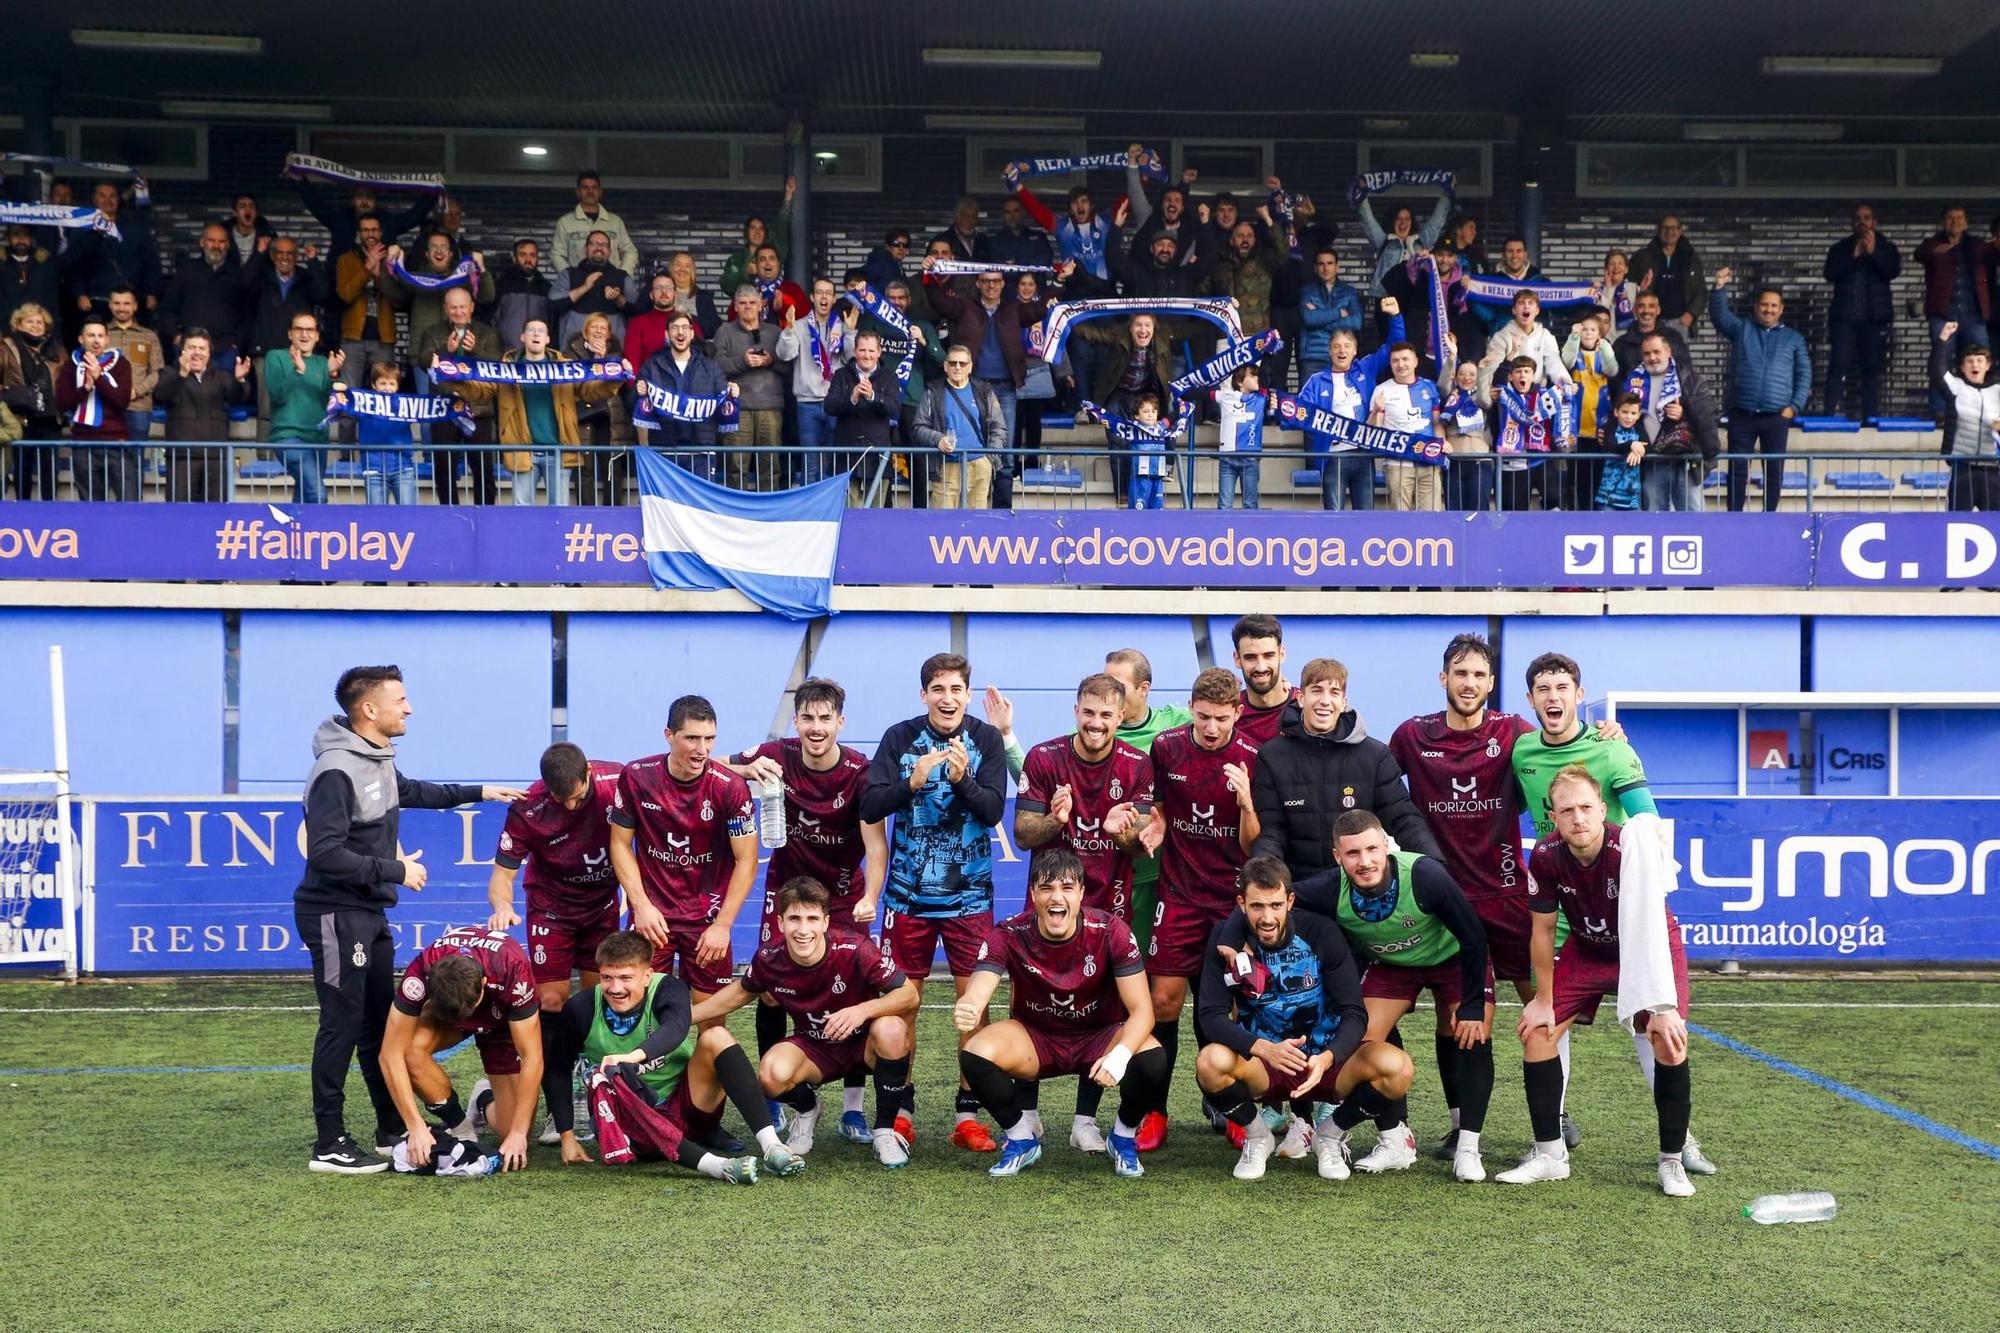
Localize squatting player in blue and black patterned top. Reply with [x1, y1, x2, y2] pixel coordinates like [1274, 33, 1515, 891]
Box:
[1194, 857, 1410, 1181]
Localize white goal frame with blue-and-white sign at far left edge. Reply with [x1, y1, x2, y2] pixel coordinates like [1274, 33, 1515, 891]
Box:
[0, 644, 78, 979]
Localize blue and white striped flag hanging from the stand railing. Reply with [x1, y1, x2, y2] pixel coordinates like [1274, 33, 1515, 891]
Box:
[636, 448, 848, 620]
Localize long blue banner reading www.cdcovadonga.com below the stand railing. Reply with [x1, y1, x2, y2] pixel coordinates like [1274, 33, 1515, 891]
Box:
[0, 502, 2000, 588]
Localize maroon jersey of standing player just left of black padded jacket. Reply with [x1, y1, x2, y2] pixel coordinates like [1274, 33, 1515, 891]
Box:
[1152, 723, 1256, 921]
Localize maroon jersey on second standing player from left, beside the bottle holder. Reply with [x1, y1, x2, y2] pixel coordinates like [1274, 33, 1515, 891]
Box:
[612, 755, 756, 925]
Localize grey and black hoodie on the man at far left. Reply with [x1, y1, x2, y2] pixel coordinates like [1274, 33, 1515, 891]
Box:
[292, 717, 480, 911]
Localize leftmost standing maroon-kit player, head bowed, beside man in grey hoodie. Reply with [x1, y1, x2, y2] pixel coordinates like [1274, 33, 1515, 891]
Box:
[486, 741, 622, 1145]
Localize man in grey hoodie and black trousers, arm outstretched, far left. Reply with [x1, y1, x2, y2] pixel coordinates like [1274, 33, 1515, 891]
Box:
[292, 667, 524, 1175]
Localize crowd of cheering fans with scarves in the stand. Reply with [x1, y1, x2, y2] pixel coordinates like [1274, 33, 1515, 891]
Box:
[0, 146, 2000, 508]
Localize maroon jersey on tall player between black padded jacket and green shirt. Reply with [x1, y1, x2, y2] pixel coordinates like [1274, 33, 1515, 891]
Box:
[1388, 709, 1534, 899]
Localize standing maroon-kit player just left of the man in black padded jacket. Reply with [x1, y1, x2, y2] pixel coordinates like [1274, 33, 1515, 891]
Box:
[1138, 667, 1258, 1153]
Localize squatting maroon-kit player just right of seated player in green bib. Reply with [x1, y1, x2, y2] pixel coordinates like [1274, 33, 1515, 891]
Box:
[694, 875, 918, 1169]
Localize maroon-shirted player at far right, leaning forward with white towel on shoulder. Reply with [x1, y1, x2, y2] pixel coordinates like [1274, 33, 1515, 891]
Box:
[1498, 765, 1694, 1199]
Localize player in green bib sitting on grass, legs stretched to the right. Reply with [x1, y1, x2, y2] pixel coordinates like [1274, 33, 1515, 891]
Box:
[550, 931, 806, 1185]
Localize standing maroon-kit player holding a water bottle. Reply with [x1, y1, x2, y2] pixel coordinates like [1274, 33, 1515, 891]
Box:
[722, 677, 888, 1143]
